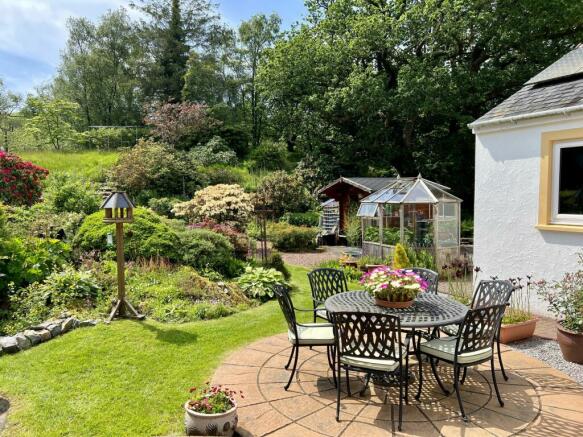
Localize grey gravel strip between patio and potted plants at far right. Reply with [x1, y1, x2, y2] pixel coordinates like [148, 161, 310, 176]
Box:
[509, 337, 583, 386]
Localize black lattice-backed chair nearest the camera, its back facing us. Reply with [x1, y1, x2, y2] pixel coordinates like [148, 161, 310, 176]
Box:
[330, 312, 410, 431]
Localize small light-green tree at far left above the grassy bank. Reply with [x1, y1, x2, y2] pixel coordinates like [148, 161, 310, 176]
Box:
[24, 97, 79, 150]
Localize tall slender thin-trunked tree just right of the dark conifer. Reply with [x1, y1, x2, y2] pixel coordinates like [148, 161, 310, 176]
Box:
[239, 14, 281, 147]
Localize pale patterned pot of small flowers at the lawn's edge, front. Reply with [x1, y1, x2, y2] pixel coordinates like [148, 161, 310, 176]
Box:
[184, 382, 244, 436]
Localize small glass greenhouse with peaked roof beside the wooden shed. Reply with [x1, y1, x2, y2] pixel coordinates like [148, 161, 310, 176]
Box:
[357, 175, 462, 261]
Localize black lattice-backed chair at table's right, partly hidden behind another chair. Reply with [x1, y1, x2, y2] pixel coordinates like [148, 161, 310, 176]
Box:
[441, 280, 514, 384]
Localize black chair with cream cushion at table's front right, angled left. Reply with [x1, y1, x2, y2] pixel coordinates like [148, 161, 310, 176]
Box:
[415, 304, 506, 422]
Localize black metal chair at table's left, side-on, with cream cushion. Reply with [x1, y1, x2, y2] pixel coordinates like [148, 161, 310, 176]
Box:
[273, 285, 336, 391]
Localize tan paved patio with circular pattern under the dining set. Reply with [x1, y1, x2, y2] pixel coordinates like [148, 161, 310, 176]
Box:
[213, 335, 583, 437]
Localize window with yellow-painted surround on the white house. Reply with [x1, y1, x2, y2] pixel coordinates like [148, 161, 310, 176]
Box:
[537, 129, 583, 232]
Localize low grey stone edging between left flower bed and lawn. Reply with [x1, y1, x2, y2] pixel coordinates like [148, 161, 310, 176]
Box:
[0, 314, 97, 355]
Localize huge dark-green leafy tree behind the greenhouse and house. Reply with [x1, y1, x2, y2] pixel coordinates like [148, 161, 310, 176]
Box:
[258, 0, 583, 208]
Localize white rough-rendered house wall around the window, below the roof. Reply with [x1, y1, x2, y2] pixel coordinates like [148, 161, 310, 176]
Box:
[474, 114, 583, 315]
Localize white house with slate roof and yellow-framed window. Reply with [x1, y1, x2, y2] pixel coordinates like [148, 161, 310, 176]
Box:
[469, 45, 583, 314]
